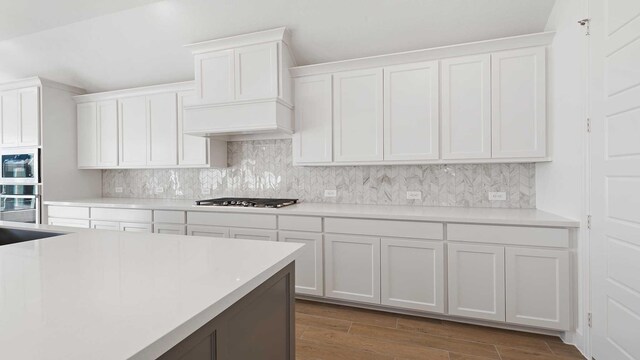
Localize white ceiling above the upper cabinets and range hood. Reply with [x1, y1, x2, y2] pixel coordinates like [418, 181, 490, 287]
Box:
[0, 0, 555, 92]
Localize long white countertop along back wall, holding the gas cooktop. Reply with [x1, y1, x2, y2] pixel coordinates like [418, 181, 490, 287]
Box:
[44, 198, 580, 227]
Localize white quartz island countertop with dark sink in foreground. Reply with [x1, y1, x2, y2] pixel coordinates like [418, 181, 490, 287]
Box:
[0, 222, 302, 360]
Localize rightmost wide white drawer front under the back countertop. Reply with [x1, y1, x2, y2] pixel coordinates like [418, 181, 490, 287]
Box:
[447, 224, 569, 248]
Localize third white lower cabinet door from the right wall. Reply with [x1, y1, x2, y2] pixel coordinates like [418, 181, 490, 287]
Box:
[380, 238, 444, 313]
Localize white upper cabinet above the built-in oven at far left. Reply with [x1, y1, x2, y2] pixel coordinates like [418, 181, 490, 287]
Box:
[0, 86, 40, 147]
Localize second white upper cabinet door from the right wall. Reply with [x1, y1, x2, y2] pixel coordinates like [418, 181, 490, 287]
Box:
[440, 55, 491, 159]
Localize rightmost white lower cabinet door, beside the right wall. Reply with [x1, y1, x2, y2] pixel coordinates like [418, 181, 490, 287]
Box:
[505, 247, 571, 330]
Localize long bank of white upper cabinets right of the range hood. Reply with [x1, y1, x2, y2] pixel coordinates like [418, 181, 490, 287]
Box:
[290, 33, 553, 165]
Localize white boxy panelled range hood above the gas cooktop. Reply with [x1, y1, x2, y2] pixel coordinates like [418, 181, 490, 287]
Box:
[184, 27, 295, 137]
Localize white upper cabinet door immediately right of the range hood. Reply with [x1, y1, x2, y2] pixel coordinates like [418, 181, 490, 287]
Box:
[293, 75, 333, 164]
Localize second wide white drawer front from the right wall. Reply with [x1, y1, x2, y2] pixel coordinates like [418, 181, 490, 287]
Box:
[324, 218, 444, 240]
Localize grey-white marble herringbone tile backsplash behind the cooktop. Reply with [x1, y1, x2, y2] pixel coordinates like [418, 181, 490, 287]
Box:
[102, 140, 536, 208]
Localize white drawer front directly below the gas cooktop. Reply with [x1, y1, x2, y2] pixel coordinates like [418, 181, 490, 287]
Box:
[187, 211, 276, 229]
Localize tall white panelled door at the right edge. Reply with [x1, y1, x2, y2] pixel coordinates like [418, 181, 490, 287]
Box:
[589, 0, 640, 360]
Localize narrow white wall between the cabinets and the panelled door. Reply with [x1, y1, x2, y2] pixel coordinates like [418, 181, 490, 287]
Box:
[536, 0, 591, 358]
